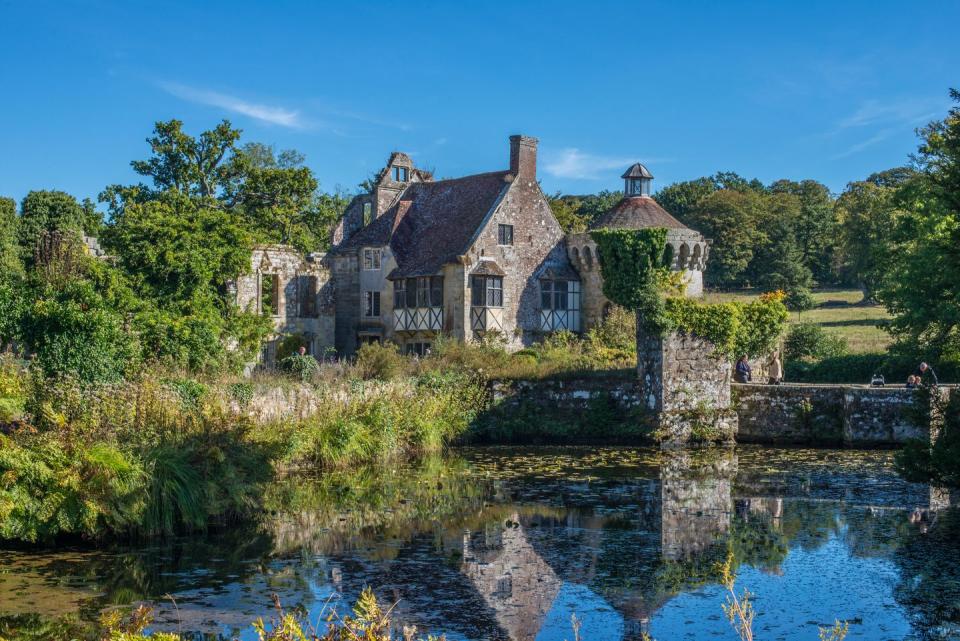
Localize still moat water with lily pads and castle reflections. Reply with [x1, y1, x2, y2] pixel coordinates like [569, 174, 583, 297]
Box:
[0, 447, 960, 641]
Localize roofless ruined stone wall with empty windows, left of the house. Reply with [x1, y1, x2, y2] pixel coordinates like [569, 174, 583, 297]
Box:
[230, 245, 334, 365]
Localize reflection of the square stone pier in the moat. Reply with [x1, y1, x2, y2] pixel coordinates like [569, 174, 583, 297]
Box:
[660, 450, 737, 560]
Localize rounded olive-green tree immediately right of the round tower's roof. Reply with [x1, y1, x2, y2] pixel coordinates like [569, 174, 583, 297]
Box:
[686, 189, 764, 287]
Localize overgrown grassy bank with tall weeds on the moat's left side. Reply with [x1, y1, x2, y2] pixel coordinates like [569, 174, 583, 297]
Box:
[0, 358, 485, 543]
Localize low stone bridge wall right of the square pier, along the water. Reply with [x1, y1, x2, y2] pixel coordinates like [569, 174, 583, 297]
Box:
[732, 384, 952, 447]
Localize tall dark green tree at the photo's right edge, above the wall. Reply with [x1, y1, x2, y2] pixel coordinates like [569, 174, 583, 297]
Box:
[877, 90, 960, 354]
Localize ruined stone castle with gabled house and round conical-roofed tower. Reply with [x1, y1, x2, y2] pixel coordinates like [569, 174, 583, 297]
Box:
[233, 136, 710, 363]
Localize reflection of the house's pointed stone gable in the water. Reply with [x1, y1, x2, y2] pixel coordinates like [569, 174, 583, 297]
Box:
[461, 514, 563, 641]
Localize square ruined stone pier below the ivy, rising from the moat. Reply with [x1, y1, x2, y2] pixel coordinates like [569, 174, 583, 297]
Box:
[637, 329, 737, 447]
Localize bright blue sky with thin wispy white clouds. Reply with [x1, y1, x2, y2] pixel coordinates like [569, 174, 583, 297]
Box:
[0, 0, 960, 205]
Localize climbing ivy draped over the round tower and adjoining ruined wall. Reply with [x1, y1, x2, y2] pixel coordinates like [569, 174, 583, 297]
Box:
[591, 228, 787, 357]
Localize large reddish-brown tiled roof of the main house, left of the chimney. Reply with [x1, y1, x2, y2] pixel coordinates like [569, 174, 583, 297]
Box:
[334, 171, 510, 278]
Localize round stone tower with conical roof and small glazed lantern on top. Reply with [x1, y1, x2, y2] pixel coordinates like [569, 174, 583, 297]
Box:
[567, 162, 710, 329]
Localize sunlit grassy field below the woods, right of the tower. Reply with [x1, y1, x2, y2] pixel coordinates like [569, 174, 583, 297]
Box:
[704, 289, 892, 354]
